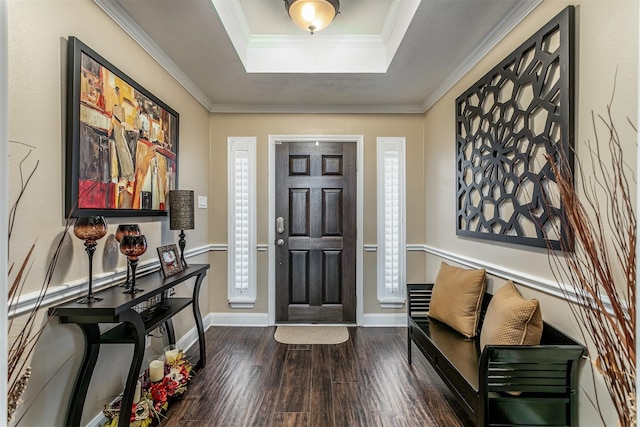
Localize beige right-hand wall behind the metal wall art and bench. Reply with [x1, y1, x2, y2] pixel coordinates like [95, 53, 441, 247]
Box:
[424, 0, 638, 425]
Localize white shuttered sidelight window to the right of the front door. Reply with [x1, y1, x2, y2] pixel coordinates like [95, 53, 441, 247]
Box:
[377, 138, 406, 308]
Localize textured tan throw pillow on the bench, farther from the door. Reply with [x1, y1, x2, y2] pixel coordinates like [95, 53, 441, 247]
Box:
[480, 280, 542, 349]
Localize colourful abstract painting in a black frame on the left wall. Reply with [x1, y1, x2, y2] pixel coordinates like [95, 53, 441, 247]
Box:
[65, 36, 180, 217]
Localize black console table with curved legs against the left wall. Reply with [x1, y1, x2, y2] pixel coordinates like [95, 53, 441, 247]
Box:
[49, 264, 209, 427]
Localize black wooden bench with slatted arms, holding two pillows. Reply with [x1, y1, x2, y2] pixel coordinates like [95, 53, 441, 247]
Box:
[407, 284, 584, 426]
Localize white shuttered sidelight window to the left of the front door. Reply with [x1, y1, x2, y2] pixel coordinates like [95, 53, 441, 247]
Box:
[228, 137, 257, 308]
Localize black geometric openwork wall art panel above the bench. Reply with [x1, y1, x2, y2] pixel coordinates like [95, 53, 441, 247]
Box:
[456, 6, 574, 249]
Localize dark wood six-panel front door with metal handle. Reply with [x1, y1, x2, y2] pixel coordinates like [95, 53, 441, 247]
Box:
[274, 142, 357, 322]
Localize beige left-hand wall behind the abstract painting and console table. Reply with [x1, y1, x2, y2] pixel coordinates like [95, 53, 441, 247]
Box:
[8, 0, 209, 426]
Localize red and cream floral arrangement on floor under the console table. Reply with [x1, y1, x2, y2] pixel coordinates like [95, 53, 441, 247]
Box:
[103, 351, 192, 427]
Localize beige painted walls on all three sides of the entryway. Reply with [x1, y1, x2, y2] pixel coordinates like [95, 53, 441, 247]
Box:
[3, 0, 638, 425]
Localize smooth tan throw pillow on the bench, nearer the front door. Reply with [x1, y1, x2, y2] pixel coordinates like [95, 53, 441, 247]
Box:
[429, 262, 487, 338]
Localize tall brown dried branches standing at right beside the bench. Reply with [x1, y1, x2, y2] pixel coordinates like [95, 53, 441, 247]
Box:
[547, 98, 637, 427]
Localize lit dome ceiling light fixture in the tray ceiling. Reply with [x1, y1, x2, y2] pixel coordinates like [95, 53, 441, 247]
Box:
[284, 0, 340, 34]
